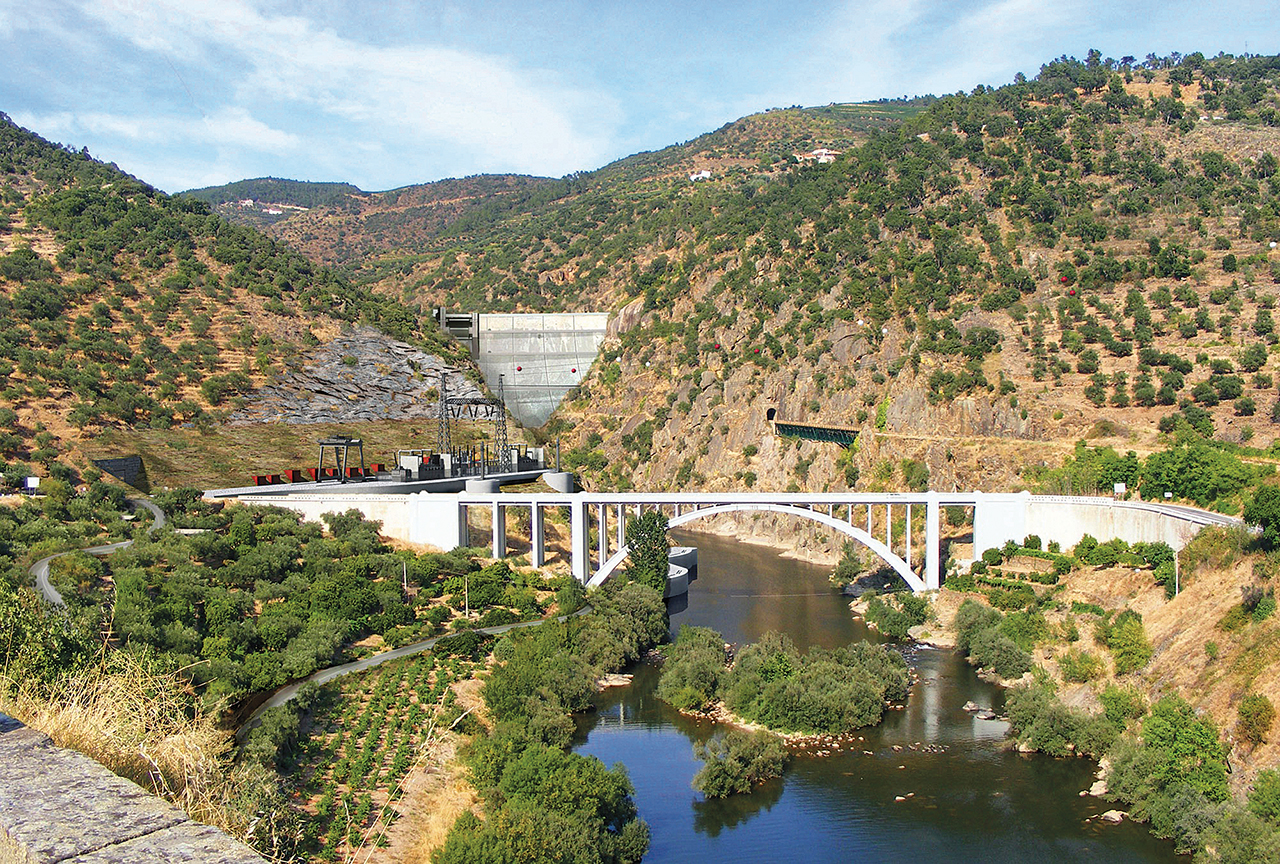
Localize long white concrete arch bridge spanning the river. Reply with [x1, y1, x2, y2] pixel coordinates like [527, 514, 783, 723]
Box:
[225, 484, 1239, 591]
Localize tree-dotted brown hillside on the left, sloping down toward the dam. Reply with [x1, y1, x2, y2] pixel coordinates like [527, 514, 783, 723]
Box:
[0, 115, 466, 480]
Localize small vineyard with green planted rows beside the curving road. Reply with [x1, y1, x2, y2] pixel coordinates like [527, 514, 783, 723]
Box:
[291, 652, 477, 861]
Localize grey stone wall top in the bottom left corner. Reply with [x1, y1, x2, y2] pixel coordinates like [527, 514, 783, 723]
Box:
[0, 714, 265, 864]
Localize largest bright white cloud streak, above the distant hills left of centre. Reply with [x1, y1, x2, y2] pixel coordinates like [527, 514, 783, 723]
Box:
[70, 0, 620, 183]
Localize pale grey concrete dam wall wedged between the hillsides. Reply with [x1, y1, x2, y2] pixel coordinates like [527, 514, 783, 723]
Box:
[440, 312, 609, 426]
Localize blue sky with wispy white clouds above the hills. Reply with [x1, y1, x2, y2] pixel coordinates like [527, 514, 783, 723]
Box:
[0, 0, 1280, 192]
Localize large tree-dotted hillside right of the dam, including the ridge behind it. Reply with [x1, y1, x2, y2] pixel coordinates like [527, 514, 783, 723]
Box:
[209, 52, 1280, 554]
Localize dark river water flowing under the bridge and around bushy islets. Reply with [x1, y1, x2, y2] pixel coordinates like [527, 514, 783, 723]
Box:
[575, 532, 1178, 864]
